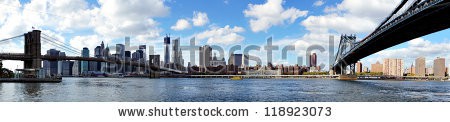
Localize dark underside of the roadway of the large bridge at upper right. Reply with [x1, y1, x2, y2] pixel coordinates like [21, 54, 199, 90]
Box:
[334, 0, 450, 69]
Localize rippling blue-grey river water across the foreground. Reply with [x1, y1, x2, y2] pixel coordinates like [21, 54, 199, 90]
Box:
[0, 78, 450, 102]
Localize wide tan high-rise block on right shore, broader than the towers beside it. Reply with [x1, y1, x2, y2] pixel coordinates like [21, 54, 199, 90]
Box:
[383, 58, 403, 76]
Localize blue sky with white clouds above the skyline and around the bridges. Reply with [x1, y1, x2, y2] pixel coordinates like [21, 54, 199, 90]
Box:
[0, 0, 450, 69]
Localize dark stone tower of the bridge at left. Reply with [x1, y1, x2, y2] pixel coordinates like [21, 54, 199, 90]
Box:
[23, 30, 42, 78]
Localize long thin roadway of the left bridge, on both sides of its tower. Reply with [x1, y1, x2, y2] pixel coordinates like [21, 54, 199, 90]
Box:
[0, 53, 186, 73]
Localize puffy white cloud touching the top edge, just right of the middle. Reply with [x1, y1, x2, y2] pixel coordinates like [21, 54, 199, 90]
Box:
[243, 0, 308, 32]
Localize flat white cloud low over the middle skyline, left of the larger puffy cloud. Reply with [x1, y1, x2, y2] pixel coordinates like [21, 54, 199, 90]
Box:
[195, 25, 245, 45]
